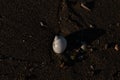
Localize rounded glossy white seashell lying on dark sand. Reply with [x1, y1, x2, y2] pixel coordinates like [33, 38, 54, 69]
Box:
[52, 35, 67, 54]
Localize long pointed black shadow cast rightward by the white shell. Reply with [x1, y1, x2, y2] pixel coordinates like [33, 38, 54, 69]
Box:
[66, 28, 106, 50]
